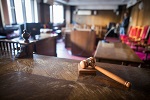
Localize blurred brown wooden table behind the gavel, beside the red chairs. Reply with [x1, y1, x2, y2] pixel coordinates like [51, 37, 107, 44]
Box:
[94, 41, 143, 66]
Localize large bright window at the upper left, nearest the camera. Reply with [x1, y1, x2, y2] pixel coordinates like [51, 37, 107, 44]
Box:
[7, 0, 38, 24]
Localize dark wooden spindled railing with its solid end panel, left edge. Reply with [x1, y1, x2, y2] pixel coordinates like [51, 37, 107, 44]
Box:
[0, 39, 33, 58]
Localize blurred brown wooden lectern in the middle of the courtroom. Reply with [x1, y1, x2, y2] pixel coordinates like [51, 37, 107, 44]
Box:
[71, 29, 96, 57]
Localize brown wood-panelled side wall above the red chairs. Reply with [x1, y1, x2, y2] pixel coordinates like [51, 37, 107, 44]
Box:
[130, 0, 150, 26]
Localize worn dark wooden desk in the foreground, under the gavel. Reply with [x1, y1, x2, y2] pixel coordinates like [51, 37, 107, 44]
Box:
[0, 54, 150, 100]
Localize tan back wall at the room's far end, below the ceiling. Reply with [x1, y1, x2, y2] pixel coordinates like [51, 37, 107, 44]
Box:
[74, 10, 120, 26]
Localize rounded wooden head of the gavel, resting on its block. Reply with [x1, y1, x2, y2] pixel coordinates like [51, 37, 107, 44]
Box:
[80, 57, 95, 69]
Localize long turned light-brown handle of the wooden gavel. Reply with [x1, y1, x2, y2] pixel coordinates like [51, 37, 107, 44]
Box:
[95, 66, 131, 87]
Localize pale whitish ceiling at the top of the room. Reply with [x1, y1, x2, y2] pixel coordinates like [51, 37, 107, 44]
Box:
[54, 0, 138, 10]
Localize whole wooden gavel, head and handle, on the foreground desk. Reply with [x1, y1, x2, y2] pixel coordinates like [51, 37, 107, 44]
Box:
[80, 57, 131, 88]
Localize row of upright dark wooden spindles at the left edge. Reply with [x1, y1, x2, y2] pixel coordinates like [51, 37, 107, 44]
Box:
[0, 40, 21, 57]
